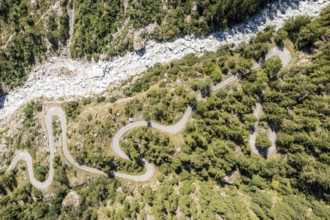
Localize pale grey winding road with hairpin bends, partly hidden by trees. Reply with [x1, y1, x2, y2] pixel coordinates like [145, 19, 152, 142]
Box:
[8, 48, 291, 189]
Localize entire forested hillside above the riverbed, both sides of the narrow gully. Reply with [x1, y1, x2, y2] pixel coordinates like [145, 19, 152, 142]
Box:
[0, 0, 271, 92]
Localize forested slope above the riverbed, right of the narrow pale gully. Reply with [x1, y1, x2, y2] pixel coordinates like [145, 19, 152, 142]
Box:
[71, 0, 272, 58]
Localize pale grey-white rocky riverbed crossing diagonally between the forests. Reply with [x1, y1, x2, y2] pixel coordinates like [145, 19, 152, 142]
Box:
[0, 0, 329, 123]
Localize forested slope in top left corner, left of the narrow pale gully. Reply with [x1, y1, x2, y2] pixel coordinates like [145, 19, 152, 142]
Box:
[0, 0, 69, 93]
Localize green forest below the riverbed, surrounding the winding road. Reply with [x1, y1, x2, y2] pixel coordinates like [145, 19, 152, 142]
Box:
[0, 7, 330, 220]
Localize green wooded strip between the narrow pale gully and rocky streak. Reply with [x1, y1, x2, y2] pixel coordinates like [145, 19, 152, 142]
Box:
[71, 0, 127, 59]
